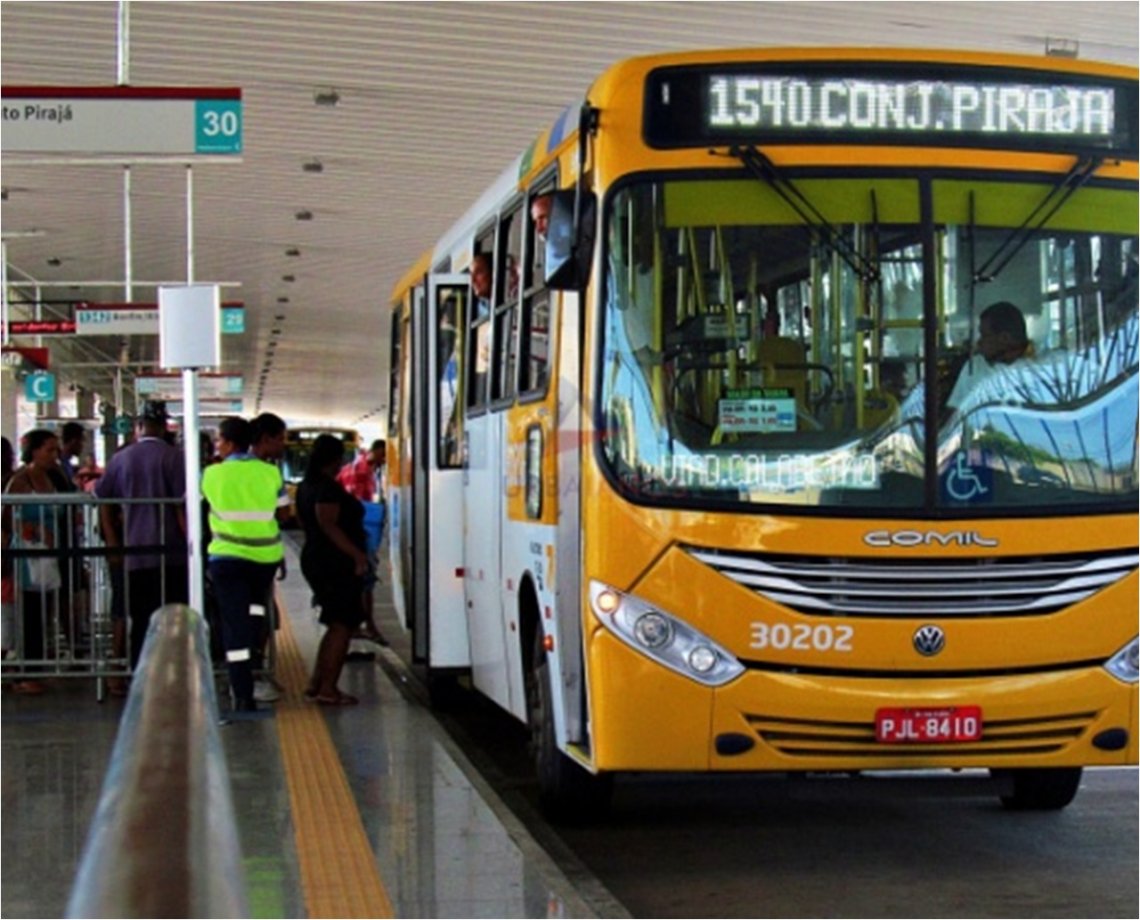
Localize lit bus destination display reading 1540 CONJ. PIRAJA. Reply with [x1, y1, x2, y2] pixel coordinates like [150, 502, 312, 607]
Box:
[645, 64, 1135, 152]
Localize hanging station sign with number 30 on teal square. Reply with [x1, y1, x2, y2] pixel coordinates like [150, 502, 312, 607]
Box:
[0, 87, 242, 156]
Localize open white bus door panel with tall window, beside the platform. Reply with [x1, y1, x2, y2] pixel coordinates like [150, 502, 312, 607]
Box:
[412, 275, 470, 668]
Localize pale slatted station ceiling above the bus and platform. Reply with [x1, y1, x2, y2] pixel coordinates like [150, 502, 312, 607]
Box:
[0, 0, 1140, 430]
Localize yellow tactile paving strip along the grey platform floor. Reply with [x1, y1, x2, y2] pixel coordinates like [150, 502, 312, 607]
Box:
[274, 593, 396, 918]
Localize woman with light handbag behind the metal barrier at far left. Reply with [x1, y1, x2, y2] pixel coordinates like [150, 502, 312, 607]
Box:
[3, 429, 59, 694]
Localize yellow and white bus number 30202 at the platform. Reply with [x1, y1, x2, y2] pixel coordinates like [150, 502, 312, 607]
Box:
[389, 48, 1138, 816]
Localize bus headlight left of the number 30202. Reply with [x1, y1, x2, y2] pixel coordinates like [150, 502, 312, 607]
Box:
[589, 581, 744, 686]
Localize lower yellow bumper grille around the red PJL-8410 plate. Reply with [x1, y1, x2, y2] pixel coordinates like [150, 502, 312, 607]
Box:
[744, 713, 1097, 758]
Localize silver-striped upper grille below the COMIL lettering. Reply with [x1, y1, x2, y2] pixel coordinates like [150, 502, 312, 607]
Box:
[687, 547, 1138, 618]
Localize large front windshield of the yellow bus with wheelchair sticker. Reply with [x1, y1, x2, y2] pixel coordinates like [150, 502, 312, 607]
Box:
[596, 176, 1138, 514]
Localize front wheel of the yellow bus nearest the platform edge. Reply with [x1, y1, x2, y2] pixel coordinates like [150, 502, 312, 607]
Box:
[527, 630, 613, 823]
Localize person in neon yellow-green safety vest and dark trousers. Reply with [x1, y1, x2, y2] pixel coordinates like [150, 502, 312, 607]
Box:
[202, 417, 285, 713]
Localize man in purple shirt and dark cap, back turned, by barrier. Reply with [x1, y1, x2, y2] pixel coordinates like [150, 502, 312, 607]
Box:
[95, 400, 189, 670]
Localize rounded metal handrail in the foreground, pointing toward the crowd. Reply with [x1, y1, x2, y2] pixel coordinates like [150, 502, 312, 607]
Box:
[67, 604, 250, 918]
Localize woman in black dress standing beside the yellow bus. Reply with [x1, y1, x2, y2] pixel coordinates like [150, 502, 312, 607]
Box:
[296, 434, 368, 706]
